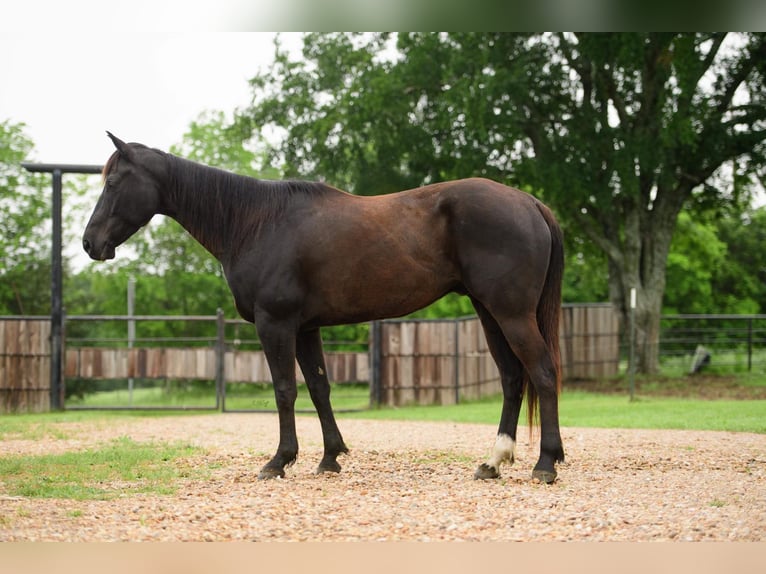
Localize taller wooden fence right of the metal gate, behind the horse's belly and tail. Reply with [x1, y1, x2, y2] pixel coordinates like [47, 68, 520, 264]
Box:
[373, 304, 620, 406]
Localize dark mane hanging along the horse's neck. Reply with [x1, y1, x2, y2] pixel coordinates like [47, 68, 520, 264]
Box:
[165, 154, 337, 257]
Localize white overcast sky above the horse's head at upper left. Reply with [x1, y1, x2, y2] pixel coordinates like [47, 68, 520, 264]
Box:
[0, 30, 300, 164]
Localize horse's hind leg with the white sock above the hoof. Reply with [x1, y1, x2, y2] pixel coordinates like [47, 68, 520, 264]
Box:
[473, 299, 524, 479]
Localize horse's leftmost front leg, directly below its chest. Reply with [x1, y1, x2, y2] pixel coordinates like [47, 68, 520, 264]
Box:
[256, 318, 298, 480]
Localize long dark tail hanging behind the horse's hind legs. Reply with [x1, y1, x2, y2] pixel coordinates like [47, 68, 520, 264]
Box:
[524, 202, 564, 431]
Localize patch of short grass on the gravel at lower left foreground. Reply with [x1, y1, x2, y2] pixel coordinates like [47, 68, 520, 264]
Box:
[0, 438, 203, 500]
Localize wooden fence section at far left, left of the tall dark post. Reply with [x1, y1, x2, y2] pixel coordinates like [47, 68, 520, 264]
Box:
[0, 319, 51, 413]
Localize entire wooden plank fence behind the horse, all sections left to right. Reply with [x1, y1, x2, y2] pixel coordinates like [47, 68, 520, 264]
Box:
[0, 305, 620, 412]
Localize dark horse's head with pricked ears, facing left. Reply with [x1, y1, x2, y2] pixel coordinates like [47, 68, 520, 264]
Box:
[82, 132, 166, 261]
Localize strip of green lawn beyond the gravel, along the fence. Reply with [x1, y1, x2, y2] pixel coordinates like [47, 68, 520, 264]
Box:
[31, 377, 766, 434]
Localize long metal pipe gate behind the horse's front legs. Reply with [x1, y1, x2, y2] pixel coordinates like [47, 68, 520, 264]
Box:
[64, 312, 370, 412]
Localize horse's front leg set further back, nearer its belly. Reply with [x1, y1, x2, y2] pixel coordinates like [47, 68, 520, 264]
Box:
[296, 329, 348, 474]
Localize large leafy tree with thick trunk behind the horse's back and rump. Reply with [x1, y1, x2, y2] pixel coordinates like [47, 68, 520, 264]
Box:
[240, 33, 766, 372]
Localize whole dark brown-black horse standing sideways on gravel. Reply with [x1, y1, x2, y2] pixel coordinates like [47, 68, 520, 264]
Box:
[83, 134, 564, 483]
